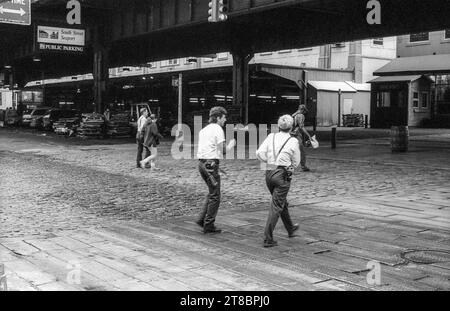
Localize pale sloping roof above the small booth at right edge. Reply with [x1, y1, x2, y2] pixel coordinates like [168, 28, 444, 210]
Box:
[373, 54, 450, 76]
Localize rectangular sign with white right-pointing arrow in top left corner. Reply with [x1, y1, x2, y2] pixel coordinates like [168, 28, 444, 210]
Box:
[0, 0, 31, 25]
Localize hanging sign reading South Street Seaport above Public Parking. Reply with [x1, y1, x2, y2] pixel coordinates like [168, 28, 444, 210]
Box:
[36, 26, 85, 52]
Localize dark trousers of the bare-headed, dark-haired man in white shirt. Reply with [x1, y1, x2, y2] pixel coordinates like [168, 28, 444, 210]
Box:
[198, 160, 220, 229]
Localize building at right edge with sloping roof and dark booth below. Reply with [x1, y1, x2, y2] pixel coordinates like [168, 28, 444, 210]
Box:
[371, 29, 450, 127]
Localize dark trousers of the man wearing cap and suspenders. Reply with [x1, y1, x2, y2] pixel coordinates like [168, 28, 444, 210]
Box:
[264, 169, 293, 242]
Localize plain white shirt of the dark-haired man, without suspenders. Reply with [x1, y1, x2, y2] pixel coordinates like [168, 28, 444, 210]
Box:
[197, 123, 225, 159]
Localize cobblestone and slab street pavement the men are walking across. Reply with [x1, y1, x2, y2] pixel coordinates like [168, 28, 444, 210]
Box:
[0, 131, 450, 290]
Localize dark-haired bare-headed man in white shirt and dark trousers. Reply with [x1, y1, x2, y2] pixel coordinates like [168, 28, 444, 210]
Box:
[196, 107, 236, 233]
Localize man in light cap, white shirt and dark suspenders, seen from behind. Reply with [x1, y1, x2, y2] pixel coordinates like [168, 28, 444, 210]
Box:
[256, 115, 300, 247]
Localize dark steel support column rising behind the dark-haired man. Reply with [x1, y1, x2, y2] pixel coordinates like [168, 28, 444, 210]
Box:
[232, 50, 253, 125]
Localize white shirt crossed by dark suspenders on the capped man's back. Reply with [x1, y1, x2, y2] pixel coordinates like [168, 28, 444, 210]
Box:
[256, 132, 300, 169]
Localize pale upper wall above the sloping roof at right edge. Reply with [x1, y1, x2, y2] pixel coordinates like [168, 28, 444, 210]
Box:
[397, 30, 450, 57]
